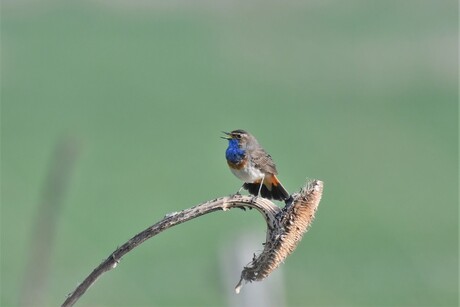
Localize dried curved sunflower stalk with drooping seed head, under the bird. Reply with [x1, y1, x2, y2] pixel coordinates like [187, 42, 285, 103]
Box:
[62, 180, 323, 306]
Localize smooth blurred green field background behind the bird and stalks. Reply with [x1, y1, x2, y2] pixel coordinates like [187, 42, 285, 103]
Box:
[0, 0, 458, 306]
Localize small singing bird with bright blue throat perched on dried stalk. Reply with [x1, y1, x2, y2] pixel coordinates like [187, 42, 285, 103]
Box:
[222, 129, 292, 204]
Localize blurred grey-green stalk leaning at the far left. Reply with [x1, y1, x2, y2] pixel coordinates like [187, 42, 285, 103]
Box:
[20, 137, 78, 306]
